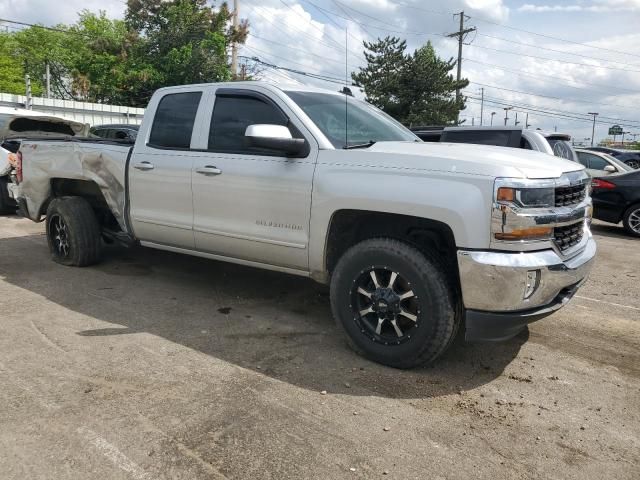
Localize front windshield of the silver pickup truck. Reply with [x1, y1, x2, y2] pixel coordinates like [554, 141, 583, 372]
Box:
[286, 91, 420, 148]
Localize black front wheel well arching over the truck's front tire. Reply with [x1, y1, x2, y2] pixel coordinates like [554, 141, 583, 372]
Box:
[325, 210, 460, 288]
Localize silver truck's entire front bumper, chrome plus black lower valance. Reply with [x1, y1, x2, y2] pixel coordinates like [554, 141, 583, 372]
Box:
[458, 235, 596, 340]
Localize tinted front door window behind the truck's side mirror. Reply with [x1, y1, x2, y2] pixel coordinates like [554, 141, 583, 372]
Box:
[209, 96, 289, 155]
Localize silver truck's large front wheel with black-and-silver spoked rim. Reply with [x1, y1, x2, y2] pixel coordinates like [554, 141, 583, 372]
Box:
[331, 238, 461, 368]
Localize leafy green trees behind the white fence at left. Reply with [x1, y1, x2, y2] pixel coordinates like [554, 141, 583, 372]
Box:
[0, 0, 248, 106]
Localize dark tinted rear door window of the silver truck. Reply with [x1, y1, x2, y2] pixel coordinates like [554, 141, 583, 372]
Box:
[149, 92, 202, 148]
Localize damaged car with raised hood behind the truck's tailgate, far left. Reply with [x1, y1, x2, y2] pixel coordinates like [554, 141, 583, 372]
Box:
[0, 107, 89, 215]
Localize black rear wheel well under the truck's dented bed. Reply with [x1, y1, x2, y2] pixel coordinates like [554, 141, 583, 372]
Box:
[47, 178, 121, 232]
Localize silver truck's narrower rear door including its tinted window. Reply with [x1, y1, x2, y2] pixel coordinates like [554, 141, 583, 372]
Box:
[129, 87, 204, 249]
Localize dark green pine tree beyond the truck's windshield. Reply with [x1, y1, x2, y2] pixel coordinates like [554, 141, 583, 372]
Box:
[352, 37, 469, 125]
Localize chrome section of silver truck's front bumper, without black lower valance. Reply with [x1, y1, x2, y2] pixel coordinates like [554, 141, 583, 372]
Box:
[458, 234, 596, 313]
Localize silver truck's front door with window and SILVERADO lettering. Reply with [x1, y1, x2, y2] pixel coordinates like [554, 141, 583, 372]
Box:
[193, 89, 317, 270]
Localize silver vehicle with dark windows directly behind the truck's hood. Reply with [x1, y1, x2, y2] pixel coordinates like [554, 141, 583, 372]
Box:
[411, 127, 578, 161]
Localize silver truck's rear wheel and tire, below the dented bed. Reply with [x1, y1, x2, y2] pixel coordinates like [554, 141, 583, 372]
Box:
[46, 197, 102, 267]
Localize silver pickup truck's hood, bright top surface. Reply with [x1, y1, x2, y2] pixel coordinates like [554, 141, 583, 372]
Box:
[357, 142, 584, 178]
